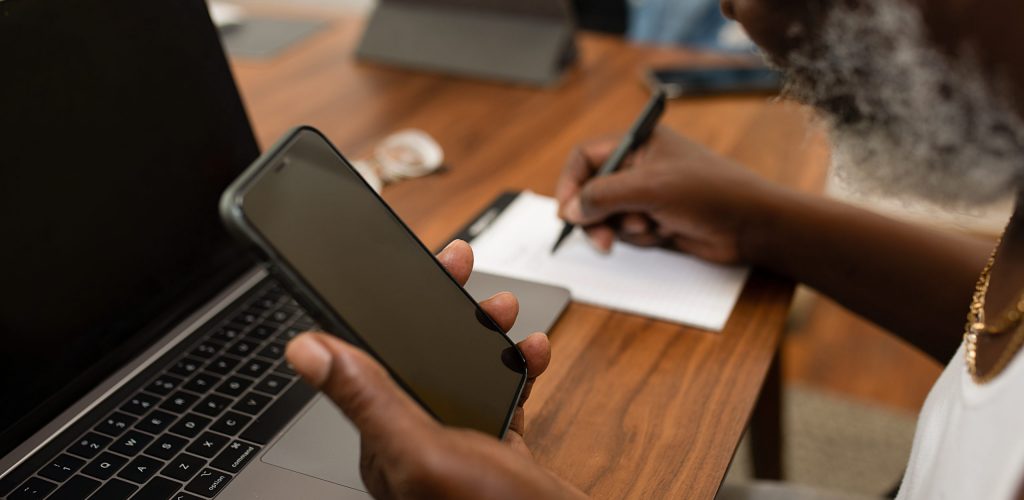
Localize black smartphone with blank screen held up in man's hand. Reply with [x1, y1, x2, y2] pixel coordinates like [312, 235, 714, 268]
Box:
[220, 126, 526, 438]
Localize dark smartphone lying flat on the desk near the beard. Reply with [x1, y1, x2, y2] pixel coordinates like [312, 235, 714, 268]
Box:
[646, 67, 782, 98]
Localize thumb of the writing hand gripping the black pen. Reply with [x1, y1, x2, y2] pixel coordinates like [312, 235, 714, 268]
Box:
[562, 169, 650, 225]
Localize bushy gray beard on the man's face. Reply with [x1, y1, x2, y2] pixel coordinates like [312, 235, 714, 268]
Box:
[777, 0, 1024, 208]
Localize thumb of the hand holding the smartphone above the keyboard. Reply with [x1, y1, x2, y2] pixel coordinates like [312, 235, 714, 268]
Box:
[286, 333, 437, 440]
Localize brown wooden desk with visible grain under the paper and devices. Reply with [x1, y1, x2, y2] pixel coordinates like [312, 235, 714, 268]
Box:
[228, 13, 826, 499]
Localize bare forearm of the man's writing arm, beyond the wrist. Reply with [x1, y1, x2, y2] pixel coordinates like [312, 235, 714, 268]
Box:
[741, 185, 993, 363]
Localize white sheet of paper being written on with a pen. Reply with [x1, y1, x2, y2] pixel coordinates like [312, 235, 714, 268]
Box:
[473, 193, 749, 331]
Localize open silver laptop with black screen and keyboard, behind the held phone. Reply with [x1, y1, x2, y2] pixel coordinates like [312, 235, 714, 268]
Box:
[0, 0, 567, 500]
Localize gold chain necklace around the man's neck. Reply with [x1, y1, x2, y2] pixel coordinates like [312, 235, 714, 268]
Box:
[964, 238, 1024, 383]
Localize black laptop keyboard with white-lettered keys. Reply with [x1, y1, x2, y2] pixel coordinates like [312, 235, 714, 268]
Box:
[7, 284, 317, 500]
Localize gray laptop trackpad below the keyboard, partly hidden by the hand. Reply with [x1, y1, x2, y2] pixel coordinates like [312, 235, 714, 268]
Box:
[262, 395, 367, 492]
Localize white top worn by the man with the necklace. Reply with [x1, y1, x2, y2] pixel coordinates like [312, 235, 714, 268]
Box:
[896, 344, 1024, 500]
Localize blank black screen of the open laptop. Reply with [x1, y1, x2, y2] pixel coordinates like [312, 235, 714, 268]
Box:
[0, 0, 258, 455]
